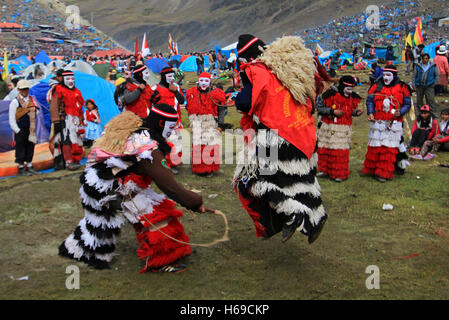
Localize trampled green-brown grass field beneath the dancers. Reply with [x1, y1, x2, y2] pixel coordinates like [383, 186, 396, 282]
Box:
[0, 66, 449, 300]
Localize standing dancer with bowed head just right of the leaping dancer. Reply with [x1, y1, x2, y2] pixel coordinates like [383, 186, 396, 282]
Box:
[317, 76, 363, 182]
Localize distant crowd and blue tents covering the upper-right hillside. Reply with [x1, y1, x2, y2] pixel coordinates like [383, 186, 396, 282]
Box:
[295, 0, 449, 53]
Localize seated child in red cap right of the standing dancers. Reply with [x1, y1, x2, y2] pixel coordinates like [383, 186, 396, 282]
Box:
[410, 105, 438, 159]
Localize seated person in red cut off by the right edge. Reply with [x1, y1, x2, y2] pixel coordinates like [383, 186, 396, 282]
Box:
[416, 108, 449, 160]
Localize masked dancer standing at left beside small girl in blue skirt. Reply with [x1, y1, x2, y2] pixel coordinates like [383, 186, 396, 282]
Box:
[50, 71, 85, 170]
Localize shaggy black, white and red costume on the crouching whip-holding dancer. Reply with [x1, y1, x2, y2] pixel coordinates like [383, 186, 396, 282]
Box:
[59, 111, 191, 273]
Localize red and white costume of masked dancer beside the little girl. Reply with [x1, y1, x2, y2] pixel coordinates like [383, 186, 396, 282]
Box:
[52, 84, 85, 163]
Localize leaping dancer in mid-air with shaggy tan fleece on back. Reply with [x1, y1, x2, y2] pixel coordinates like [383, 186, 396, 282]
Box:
[234, 34, 327, 243]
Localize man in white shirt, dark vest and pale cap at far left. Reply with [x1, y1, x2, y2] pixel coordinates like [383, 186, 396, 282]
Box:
[9, 80, 38, 175]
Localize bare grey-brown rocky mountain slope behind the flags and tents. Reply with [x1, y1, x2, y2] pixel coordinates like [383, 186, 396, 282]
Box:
[59, 0, 389, 52]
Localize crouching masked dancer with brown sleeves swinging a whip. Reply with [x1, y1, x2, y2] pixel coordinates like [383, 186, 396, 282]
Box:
[59, 104, 204, 273]
